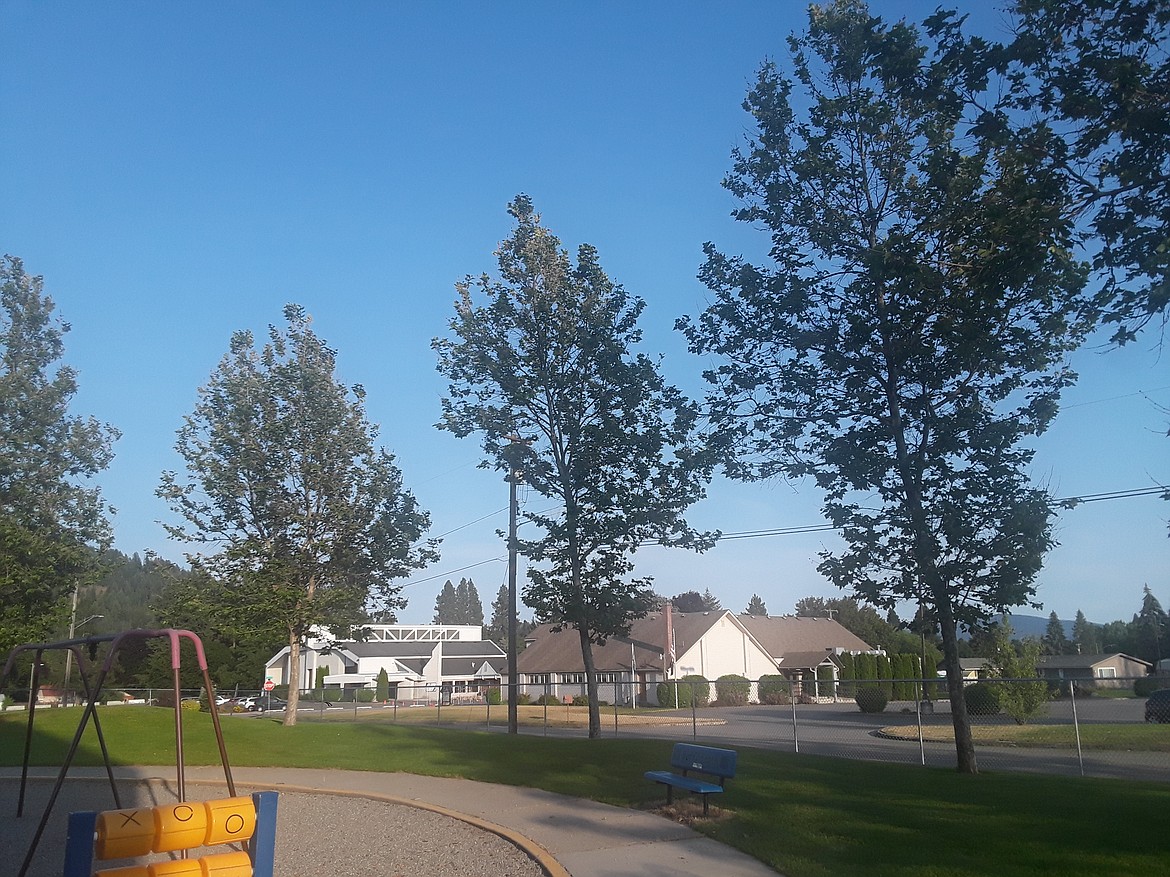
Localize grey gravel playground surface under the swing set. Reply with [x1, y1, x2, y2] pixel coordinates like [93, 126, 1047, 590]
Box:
[0, 779, 544, 877]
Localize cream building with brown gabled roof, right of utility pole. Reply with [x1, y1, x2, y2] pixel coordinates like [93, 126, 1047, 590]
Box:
[516, 610, 873, 704]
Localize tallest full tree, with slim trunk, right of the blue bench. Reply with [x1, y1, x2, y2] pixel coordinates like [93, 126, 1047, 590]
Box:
[680, 0, 1085, 773]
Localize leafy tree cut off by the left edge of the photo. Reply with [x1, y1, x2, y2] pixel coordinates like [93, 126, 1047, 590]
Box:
[0, 256, 118, 654]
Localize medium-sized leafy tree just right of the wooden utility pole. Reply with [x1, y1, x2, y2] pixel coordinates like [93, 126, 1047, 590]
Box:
[433, 195, 710, 737]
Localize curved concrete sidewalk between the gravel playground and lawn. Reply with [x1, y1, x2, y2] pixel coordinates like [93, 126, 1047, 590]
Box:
[9, 766, 776, 877]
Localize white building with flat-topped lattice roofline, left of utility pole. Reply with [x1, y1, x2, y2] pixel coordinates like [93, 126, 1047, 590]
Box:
[264, 624, 508, 702]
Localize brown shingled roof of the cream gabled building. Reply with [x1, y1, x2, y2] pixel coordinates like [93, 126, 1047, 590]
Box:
[516, 610, 870, 674]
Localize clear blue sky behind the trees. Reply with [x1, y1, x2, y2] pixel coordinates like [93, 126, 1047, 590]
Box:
[0, 0, 1170, 622]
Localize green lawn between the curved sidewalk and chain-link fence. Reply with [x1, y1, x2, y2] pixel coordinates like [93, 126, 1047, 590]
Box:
[0, 707, 1170, 877]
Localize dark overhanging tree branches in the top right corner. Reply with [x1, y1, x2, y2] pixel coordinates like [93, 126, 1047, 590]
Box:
[996, 0, 1170, 344]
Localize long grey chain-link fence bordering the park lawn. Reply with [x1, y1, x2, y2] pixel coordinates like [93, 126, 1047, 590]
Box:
[5, 677, 1170, 781]
